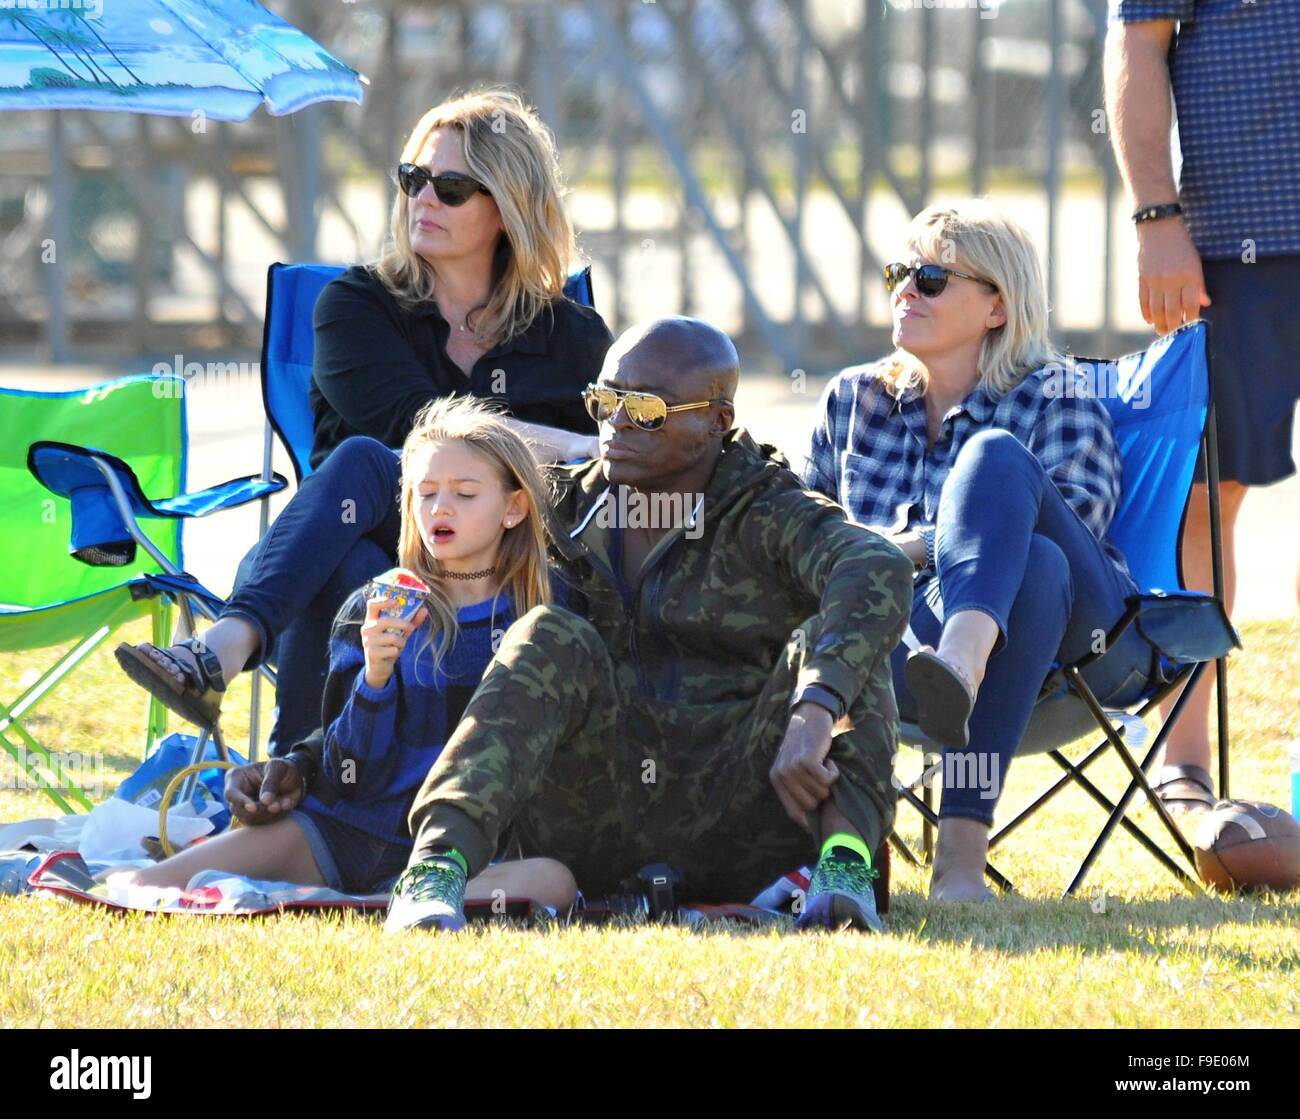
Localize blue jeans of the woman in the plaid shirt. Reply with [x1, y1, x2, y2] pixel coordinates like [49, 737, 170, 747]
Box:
[892, 430, 1153, 824]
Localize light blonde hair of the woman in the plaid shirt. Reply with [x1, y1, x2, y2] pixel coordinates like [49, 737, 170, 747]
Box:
[881, 199, 1065, 396]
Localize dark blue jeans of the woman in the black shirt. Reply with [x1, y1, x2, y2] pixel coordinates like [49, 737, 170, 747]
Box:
[221, 435, 402, 754]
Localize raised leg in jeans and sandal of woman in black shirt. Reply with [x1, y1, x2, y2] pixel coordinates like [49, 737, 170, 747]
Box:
[117, 437, 400, 721]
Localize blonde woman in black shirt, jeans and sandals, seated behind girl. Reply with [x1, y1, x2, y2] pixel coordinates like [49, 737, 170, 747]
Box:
[117, 91, 611, 752]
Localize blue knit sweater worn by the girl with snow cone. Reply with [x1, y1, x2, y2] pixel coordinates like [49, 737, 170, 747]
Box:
[303, 594, 515, 842]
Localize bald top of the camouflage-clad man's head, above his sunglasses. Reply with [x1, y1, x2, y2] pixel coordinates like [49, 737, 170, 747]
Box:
[606, 315, 740, 400]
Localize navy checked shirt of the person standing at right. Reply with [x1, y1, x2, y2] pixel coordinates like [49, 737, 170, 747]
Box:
[1112, 0, 1300, 260]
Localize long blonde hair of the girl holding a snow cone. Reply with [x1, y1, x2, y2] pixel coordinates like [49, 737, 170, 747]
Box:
[398, 396, 551, 677]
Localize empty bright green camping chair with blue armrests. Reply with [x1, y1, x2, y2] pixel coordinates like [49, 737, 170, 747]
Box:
[0, 376, 286, 812]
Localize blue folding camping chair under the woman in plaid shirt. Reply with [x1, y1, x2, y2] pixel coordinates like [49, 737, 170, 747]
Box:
[894, 321, 1240, 895]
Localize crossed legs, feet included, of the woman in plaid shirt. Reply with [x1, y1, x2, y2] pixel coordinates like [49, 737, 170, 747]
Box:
[905, 431, 1151, 899]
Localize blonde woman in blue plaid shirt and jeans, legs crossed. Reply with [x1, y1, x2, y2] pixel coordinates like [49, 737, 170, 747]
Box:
[805, 201, 1152, 901]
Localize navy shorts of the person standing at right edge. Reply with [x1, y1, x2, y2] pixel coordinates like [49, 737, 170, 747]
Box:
[1197, 256, 1300, 486]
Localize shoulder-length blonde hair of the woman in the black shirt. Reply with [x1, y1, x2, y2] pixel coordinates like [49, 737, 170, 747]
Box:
[373, 90, 576, 344]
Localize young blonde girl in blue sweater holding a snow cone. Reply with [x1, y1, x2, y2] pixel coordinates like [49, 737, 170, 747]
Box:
[119, 398, 575, 908]
